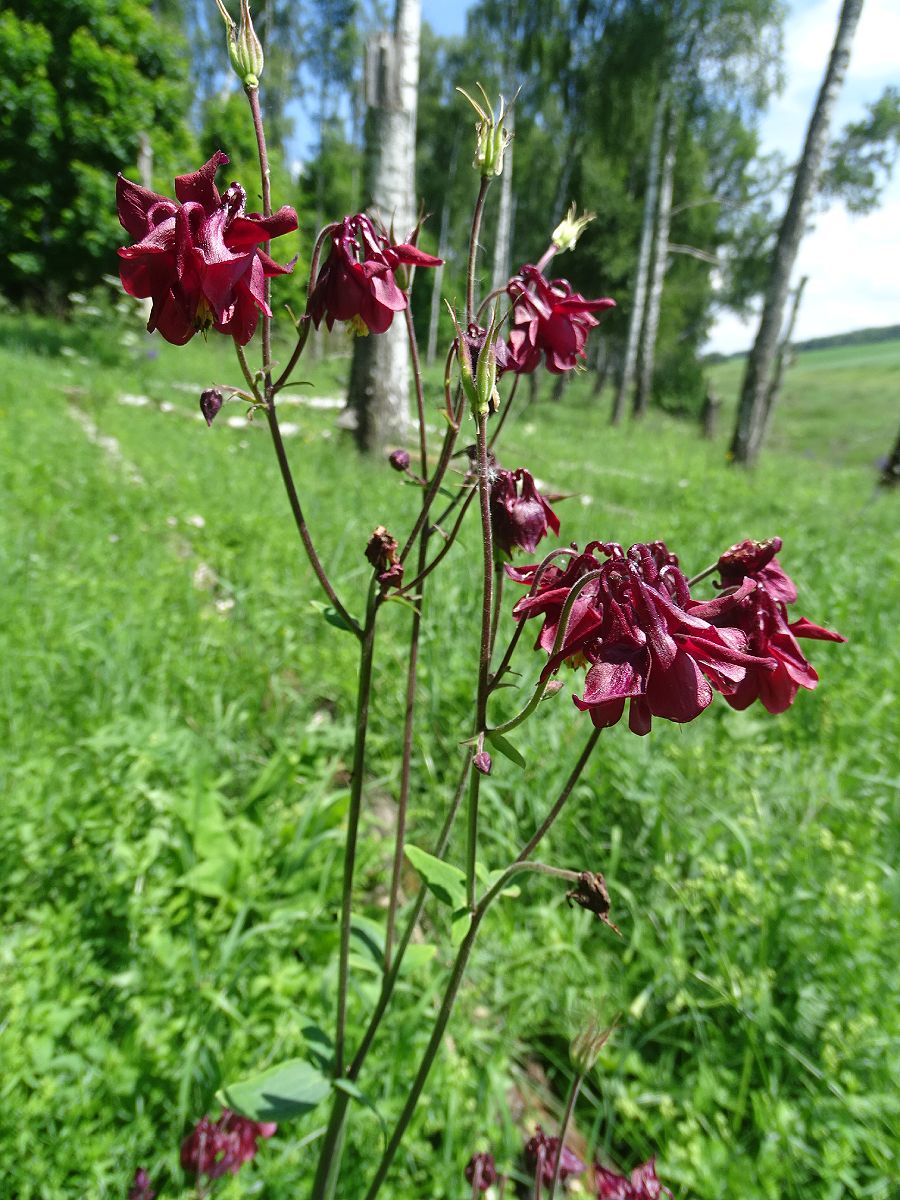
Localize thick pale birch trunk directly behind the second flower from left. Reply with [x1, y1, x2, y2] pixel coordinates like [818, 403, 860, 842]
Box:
[347, 0, 421, 452]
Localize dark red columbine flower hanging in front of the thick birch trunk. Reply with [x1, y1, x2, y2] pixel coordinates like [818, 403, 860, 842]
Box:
[310, 212, 443, 334]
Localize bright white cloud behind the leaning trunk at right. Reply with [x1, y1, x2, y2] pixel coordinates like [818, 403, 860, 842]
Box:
[709, 0, 900, 353]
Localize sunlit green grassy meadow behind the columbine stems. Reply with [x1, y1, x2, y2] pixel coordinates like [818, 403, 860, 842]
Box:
[0, 314, 900, 1200]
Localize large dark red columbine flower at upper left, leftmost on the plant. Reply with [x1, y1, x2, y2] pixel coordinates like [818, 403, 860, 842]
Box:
[115, 150, 296, 346]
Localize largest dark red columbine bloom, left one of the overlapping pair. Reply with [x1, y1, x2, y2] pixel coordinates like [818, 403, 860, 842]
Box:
[506, 542, 776, 734]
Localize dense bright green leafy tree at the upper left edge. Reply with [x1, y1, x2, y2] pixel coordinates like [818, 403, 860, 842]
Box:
[0, 0, 190, 305]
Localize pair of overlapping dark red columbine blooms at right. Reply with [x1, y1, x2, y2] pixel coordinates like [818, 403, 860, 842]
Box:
[506, 539, 842, 734]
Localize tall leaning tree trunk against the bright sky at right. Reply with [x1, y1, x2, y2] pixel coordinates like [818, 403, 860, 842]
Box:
[731, 0, 863, 466]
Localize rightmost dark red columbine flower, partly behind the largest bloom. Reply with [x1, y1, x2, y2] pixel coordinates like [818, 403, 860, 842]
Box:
[719, 538, 846, 713]
